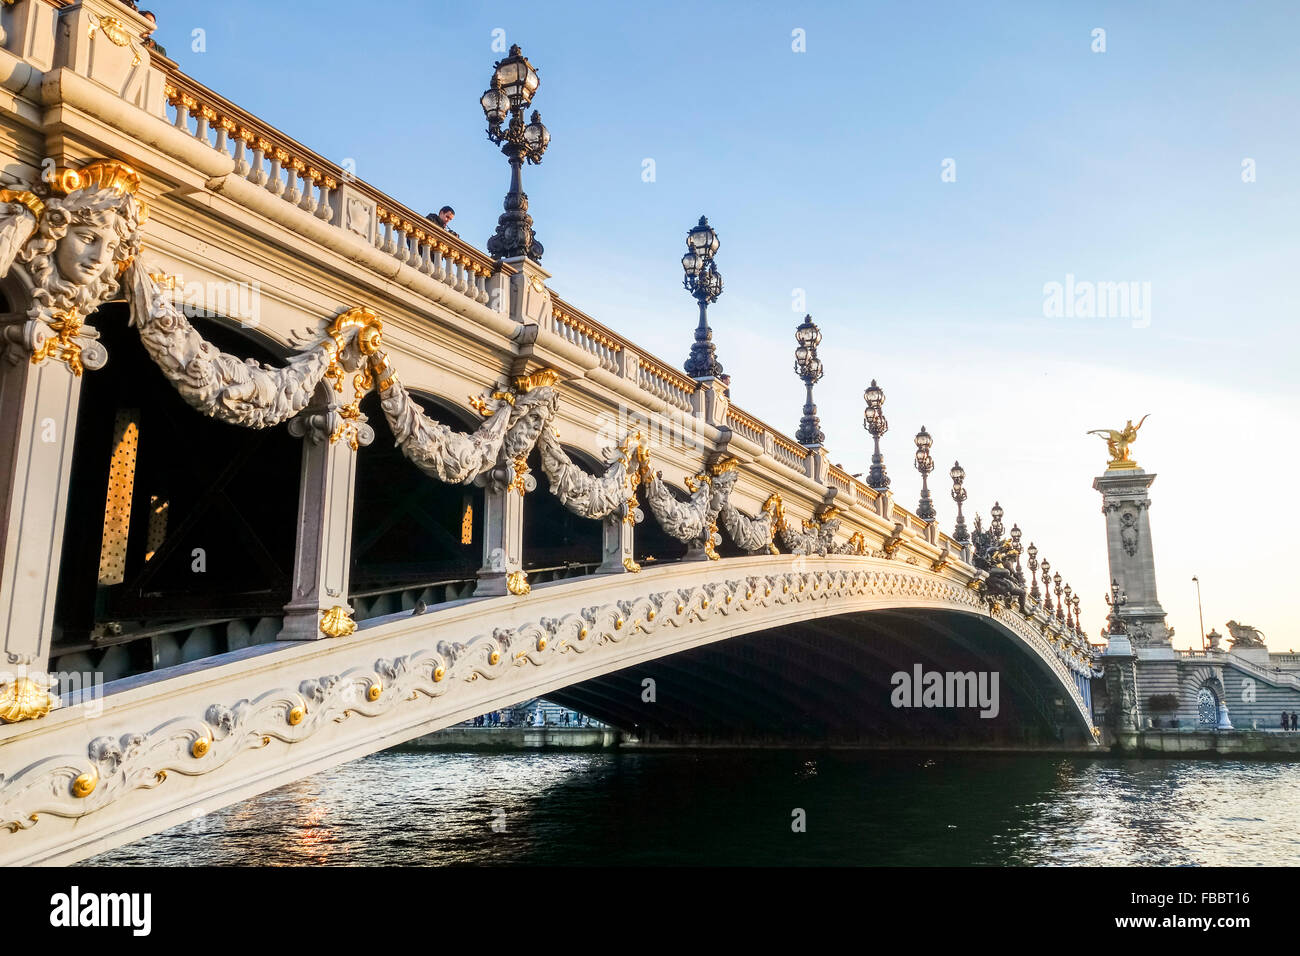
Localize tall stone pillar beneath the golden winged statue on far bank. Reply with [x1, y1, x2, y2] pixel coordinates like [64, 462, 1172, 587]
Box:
[1092, 467, 1170, 648]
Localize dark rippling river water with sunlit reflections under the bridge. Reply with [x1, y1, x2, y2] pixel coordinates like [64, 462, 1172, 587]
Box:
[88, 750, 1300, 866]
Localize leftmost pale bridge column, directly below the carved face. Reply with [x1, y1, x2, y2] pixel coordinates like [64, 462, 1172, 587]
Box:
[0, 327, 90, 672]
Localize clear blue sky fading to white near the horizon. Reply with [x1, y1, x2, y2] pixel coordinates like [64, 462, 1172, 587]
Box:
[156, 0, 1300, 650]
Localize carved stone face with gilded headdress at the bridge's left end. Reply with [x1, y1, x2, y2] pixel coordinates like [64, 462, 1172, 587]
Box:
[0, 160, 148, 375]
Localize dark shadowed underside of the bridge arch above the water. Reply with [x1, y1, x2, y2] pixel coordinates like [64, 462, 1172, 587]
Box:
[547, 610, 1088, 747]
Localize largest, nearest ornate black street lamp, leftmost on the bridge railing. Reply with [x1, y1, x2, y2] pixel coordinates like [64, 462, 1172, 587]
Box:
[478, 44, 551, 261]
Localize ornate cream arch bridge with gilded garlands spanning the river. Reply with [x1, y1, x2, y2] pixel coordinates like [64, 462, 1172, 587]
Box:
[0, 0, 1101, 864]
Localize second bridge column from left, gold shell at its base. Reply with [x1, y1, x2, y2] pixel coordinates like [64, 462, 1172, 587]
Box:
[278, 392, 374, 641]
